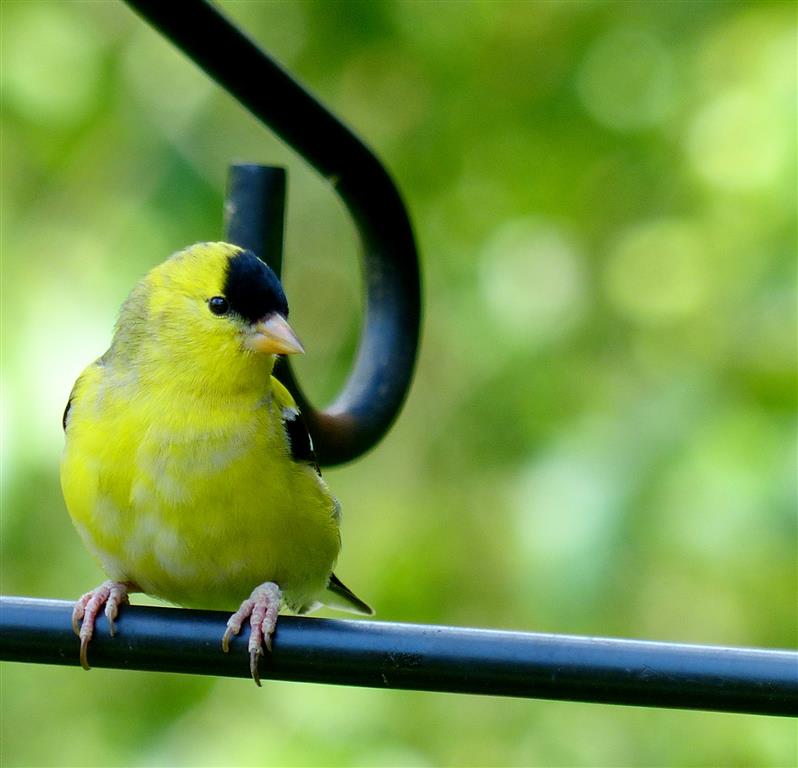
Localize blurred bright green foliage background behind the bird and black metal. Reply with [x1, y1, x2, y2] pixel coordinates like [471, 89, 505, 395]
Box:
[0, 0, 798, 768]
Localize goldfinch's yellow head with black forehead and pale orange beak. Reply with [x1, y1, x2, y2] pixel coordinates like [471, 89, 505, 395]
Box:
[110, 243, 304, 384]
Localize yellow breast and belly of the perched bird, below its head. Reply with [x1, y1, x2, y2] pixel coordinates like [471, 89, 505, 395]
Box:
[61, 364, 340, 608]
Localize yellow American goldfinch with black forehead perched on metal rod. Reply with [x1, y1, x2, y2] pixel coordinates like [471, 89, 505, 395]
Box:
[61, 243, 372, 685]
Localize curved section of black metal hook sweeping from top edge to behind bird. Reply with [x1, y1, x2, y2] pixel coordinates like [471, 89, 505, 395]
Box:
[125, 0, 421, 464]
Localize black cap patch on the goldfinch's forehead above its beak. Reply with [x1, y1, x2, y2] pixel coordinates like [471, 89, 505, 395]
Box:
[223, 251, 288, 323]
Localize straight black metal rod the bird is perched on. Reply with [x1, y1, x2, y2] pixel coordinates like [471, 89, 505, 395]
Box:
[0, 597, 798, 717]
